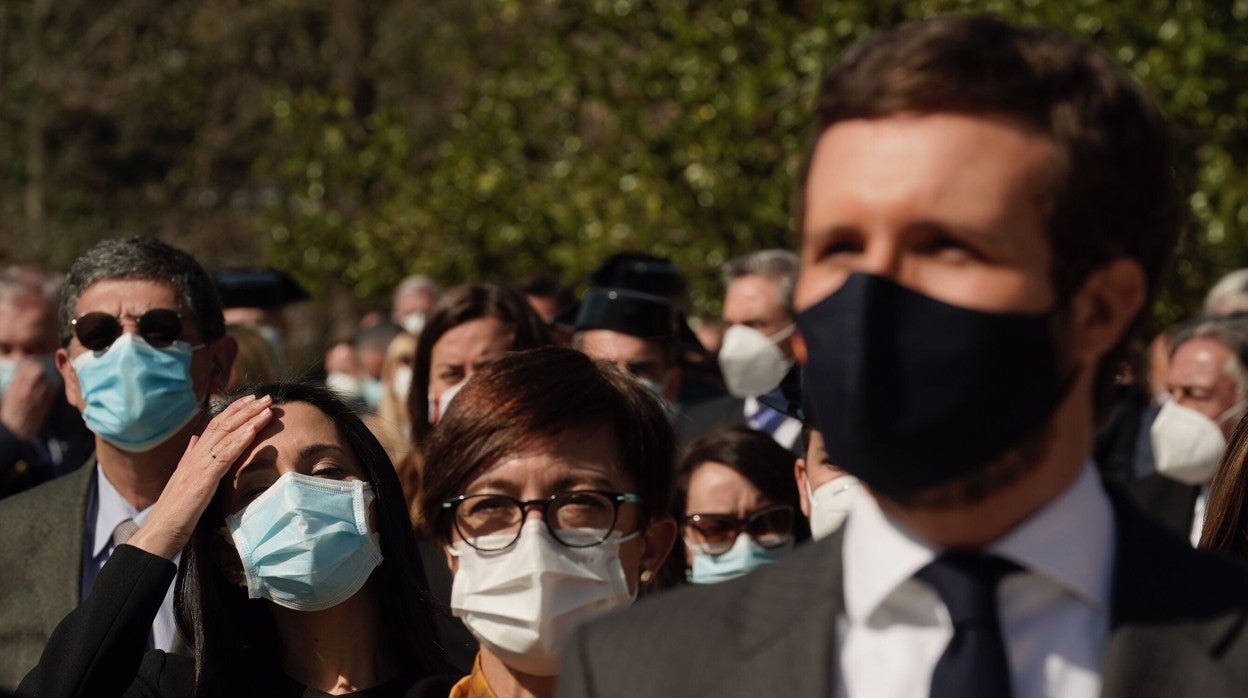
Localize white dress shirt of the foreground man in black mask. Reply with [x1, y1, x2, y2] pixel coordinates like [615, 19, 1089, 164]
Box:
[836, 463, 1116, 698]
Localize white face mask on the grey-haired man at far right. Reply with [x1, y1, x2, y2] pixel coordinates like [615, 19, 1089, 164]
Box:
[1148, 400, 1248, 484]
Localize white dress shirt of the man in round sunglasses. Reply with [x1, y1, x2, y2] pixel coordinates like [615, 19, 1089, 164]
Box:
[82, 465, 182, 652]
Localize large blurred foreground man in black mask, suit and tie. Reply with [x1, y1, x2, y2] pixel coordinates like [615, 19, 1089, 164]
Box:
[559, 15, 1248, 698]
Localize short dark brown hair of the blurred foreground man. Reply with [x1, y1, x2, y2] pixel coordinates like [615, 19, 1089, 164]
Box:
[796, 15, 1184, 397]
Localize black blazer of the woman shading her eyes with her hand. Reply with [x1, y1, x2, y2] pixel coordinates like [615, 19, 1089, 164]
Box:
[17, 544, 459, 698]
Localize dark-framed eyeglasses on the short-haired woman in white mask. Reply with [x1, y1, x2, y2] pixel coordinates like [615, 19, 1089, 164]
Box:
[442, 489, 641, 552]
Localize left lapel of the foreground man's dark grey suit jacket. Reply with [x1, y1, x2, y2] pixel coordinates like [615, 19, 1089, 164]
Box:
[731, 531, 845, 696]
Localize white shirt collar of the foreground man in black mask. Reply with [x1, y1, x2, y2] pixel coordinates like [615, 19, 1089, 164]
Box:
[844, 462, 1116, 623]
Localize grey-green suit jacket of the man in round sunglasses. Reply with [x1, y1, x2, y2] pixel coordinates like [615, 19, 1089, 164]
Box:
[0, 458, 95, 691]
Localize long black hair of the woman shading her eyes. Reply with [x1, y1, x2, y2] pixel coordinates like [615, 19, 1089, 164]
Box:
[175, 383, 454, 697]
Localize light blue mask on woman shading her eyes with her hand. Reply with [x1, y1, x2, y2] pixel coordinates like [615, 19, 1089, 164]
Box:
[226, 472, 382, 611]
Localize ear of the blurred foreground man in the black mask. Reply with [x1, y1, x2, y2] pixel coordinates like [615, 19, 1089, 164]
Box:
[1070, 257, 1148, 366]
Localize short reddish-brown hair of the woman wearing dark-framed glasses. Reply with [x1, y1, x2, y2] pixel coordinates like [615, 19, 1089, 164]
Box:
[419, 347, 675, 541]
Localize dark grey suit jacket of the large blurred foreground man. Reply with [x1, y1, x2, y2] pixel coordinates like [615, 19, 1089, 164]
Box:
[558, 489, 1248, 698]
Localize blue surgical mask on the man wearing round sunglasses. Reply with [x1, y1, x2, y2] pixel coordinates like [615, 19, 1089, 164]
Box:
[74, 332, 200, 452]
